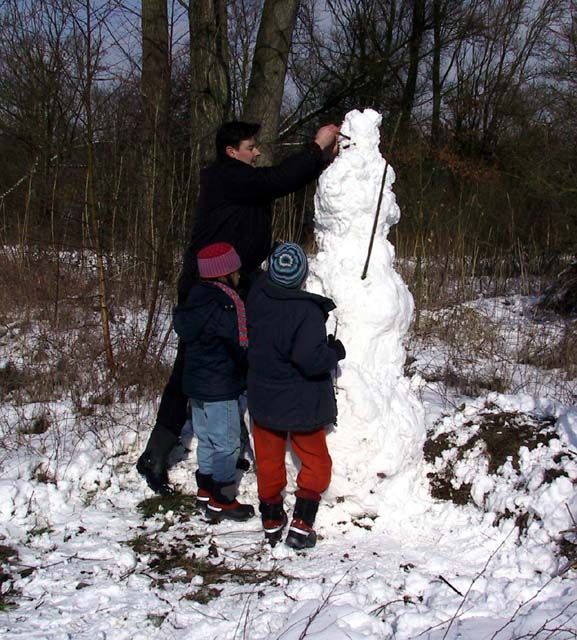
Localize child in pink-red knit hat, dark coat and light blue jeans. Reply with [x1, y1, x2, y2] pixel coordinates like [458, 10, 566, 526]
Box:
[173, 242, 254, 521]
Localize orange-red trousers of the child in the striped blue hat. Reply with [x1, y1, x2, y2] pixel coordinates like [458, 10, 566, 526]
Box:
[253, 421, 333, 502]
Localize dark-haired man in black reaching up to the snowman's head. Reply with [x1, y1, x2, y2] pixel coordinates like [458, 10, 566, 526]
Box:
[136, 121, 339, 494]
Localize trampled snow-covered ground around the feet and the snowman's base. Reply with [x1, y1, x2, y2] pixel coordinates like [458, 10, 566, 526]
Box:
[0, 297, 577, 640]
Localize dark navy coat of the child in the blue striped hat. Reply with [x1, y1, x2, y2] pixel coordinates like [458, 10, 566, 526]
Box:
[246, 275, 337, 432]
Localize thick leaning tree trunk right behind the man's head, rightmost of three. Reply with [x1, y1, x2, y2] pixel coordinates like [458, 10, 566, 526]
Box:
[242, 0, 300, 165]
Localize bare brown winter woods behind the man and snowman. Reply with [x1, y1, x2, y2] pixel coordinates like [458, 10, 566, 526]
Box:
[0, 0, 577, 375]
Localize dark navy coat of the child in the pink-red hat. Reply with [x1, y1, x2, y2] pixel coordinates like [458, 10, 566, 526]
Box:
[173, 281, 247, 402]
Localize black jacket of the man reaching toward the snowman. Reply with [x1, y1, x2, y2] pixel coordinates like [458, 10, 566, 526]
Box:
[178, 142, 325, 301]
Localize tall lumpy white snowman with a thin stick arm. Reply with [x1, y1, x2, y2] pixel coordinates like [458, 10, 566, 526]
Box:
[307, 109, 425, 513]
